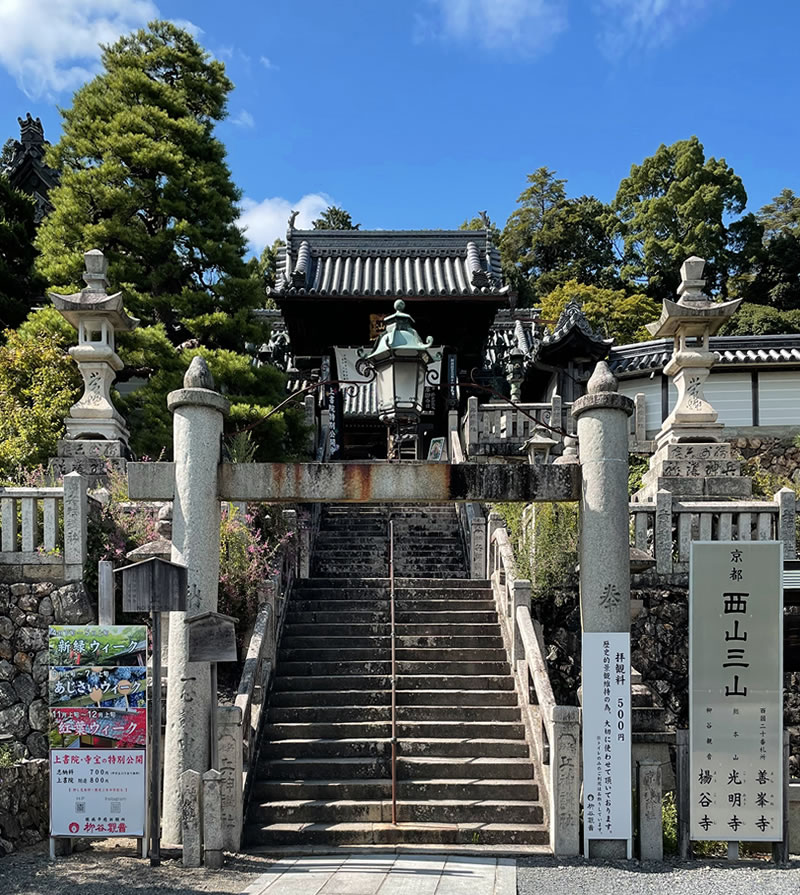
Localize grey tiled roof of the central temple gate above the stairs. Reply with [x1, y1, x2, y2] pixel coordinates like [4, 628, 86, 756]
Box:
[271, 230, 509, 296]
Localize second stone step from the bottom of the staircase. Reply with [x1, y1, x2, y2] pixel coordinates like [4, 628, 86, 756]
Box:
[250, 798, 544, 824]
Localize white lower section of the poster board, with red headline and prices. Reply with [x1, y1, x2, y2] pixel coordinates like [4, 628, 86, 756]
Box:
[50, 749, 147, 836]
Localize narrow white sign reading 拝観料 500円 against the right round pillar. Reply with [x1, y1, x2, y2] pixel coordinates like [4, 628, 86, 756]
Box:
[583, 632, 633, 857]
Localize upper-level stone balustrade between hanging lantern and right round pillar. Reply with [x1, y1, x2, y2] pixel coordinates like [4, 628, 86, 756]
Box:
[463, 395, 573, 457]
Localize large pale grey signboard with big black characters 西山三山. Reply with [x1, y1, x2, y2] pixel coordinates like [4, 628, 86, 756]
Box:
[689, 541, 783, 842]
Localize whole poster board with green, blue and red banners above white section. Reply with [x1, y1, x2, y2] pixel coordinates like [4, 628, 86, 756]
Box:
[48, 625, 147, 837]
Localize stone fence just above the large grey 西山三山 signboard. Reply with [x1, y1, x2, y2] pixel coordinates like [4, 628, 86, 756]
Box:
[630, 488, 797, 575]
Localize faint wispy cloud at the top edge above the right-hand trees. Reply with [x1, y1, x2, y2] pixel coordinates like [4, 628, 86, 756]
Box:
[597, 0, 715, 59]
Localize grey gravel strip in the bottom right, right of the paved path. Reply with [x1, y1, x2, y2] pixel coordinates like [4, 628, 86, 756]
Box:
[517, 857, 800, 895]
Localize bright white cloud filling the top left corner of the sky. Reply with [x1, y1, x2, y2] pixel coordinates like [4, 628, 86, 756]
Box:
[0, 0, 200, 99]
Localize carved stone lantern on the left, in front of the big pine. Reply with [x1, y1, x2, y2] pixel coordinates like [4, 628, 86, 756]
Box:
[50, 249, 139, 482]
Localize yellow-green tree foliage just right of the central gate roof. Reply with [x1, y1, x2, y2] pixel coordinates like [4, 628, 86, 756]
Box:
[541, 280, 661, 345]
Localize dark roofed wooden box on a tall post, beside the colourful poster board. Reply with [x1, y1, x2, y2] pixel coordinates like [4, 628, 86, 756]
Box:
[114, 556, 187, 867]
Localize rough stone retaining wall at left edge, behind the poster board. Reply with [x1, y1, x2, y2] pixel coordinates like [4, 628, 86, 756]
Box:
[0, 582, 94, 758]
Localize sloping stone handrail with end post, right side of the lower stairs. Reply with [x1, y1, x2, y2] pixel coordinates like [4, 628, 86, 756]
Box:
[489, 513, 580, 856]
